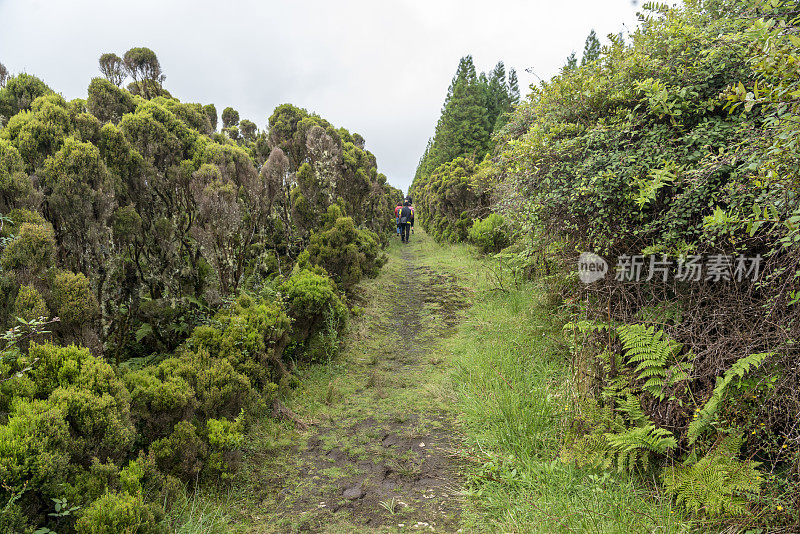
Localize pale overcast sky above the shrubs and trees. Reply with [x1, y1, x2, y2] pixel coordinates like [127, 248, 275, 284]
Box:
[0, 0, 637, 190]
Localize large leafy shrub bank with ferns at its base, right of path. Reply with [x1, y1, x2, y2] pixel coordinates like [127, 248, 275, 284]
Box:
[492, 0, 800, 530]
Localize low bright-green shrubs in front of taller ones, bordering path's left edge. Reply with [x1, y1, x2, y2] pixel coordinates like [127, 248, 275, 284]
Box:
[0, 258, 358, 533]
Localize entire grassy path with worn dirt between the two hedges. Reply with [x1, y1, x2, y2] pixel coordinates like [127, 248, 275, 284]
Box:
[192, 232, 690, 534]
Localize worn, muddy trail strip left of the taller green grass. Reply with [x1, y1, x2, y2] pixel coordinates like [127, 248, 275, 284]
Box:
[231, 232, 467, 533]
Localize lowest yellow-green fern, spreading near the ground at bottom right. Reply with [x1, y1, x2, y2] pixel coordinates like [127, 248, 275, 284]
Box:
[662, 435, 761, 515]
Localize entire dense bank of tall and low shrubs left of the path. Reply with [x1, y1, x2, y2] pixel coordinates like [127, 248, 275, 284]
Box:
[0, 49, 392, 532]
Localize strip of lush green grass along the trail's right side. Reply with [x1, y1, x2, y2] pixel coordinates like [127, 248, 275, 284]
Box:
[416, 245, 691, 533]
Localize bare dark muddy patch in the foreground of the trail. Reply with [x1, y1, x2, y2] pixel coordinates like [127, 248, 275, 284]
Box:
[282, 414, 460, 532]
